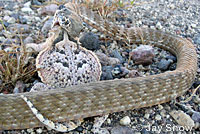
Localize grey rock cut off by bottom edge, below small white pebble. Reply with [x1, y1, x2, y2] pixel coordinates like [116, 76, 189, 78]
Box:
[111, 126, 134, 134]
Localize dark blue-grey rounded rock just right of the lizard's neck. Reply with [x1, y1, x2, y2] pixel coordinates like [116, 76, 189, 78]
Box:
[79, 32, 100, 50]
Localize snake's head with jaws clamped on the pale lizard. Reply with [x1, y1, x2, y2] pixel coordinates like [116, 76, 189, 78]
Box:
[52, 5, 83, 38]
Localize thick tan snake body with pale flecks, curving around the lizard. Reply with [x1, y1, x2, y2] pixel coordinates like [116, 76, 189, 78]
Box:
[0, 2, 197, 130]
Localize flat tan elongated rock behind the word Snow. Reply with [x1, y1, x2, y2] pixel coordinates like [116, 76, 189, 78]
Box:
[169, 110, 195, 127]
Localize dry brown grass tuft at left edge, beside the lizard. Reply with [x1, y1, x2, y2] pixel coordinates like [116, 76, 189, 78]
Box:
[0, 20, 36, 93]
